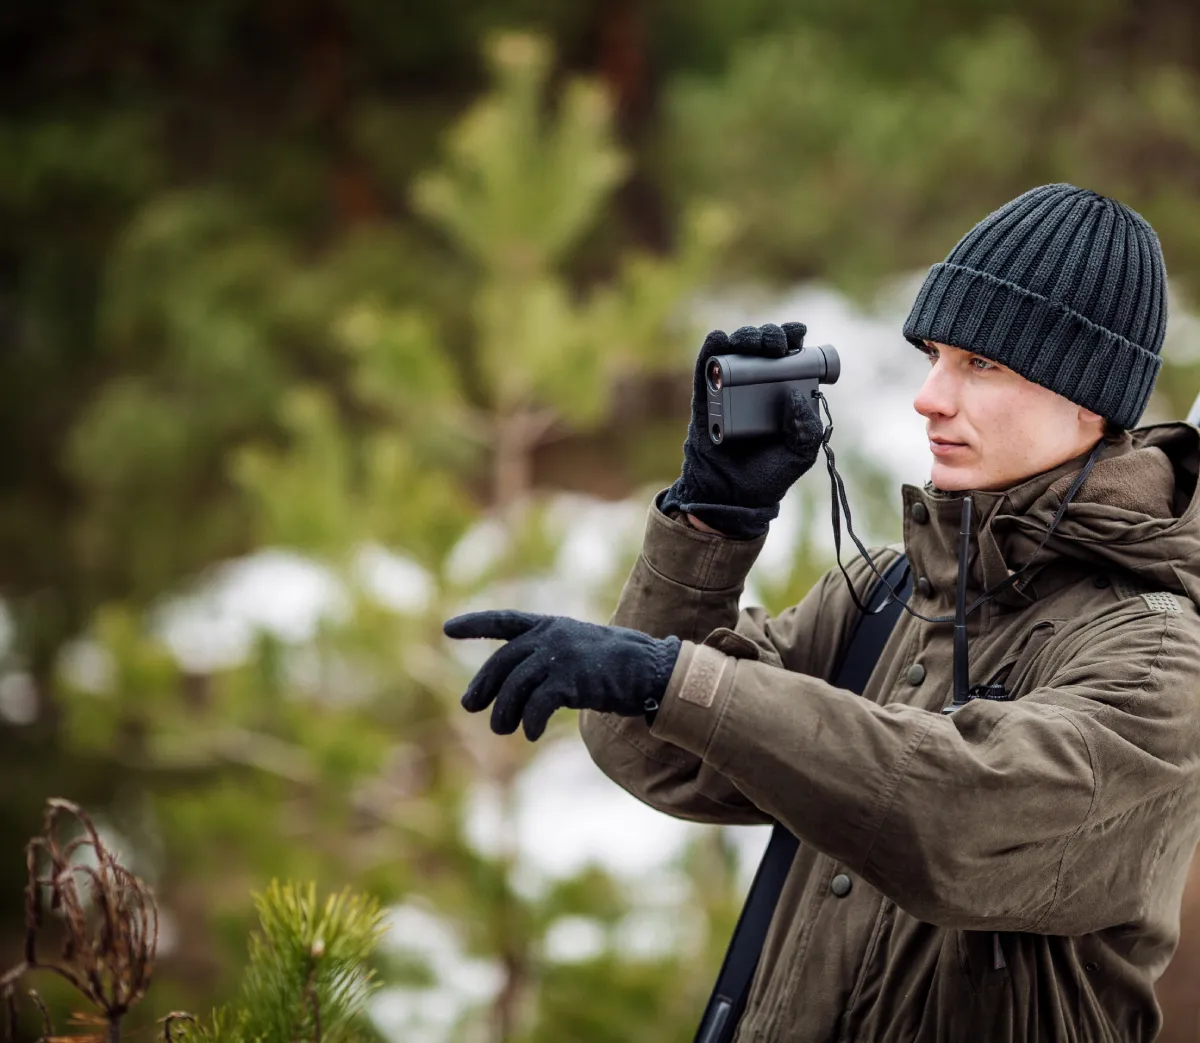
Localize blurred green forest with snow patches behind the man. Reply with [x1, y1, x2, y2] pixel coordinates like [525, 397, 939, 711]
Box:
[7, 0, 1200, 1043]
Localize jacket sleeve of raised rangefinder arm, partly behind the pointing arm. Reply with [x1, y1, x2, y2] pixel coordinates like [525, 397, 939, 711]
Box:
[580, 492, 892, 825]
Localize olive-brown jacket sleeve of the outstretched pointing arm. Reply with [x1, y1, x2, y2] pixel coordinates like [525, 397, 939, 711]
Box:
[652, 600, 1200, 935]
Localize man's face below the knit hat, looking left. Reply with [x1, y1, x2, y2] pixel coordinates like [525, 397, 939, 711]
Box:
[912, 341, 1104, 492]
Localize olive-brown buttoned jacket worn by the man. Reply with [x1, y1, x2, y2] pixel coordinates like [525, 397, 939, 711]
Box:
[581, 424, 1200, 1043]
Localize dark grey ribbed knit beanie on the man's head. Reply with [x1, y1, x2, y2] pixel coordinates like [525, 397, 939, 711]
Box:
[904, 185, 1166, 427]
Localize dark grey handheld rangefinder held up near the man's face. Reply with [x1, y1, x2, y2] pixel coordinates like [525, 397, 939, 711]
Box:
[704, 344, 841, 445]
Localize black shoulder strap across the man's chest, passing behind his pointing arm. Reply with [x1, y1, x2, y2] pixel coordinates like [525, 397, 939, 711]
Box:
[695, 555, 912, 1043]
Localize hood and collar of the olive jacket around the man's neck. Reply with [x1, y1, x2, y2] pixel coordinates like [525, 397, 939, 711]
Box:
[904, 424, 1200, 606]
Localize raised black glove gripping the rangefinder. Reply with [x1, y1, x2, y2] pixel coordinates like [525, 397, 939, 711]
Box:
[658, 323, 823, 540]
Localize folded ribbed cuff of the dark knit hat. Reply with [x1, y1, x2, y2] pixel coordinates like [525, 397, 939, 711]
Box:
[904, 263, 1162, 427]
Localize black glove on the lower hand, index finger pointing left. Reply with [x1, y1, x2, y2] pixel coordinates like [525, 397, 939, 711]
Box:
[442, 611, 680, 742]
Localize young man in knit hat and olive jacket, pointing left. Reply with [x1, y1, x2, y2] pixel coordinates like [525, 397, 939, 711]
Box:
[446, 185, 1200, 1043]
